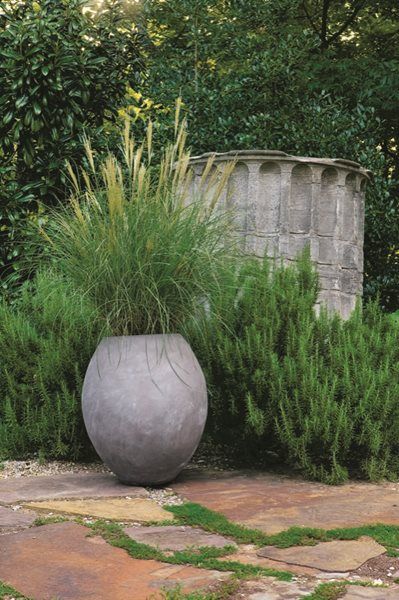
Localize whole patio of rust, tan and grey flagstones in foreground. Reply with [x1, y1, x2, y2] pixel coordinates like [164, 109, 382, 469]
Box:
[0, 469, 399, 600]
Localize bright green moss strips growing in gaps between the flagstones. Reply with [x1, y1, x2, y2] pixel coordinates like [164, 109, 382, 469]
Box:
[30, 502, 399, 600]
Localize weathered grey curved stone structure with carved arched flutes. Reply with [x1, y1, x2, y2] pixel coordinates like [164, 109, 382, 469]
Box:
[190, 150, 369, 318]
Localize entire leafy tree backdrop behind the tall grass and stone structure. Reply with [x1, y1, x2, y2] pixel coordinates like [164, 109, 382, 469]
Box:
[0, 0, 399, 311]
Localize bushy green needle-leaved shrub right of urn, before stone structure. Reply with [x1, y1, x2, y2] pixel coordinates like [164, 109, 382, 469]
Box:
[190, 252, 399, 483]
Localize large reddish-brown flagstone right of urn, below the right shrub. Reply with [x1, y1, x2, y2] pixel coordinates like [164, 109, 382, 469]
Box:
[170, 470, 399, 532]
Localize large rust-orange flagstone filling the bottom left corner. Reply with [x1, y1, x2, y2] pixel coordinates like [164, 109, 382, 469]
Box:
[0, 522, 228, 600]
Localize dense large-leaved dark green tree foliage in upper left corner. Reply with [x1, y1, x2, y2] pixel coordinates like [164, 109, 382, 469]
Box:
[0, 0, 142, 292]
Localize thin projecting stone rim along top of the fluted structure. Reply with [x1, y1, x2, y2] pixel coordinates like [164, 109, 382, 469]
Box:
[189, 149, 373, 179]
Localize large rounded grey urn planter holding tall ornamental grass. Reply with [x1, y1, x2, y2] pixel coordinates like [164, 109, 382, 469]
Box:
[82, 335, 208, 485]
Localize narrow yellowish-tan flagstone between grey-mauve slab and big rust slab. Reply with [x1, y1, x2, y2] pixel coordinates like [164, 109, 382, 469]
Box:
[27, 498, 173, 522]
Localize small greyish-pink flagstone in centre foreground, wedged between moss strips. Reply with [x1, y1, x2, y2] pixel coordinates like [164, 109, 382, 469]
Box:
[125, 525, 235, 550]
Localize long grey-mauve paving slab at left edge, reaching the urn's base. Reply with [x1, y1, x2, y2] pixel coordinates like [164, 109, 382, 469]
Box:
[0, 473, 148, 504]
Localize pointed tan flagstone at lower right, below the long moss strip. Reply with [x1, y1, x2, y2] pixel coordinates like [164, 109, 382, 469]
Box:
[258, 538, 386, 572]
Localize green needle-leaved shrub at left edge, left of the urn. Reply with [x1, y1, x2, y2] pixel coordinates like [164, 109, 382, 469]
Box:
[0, 272, 100, 459]
